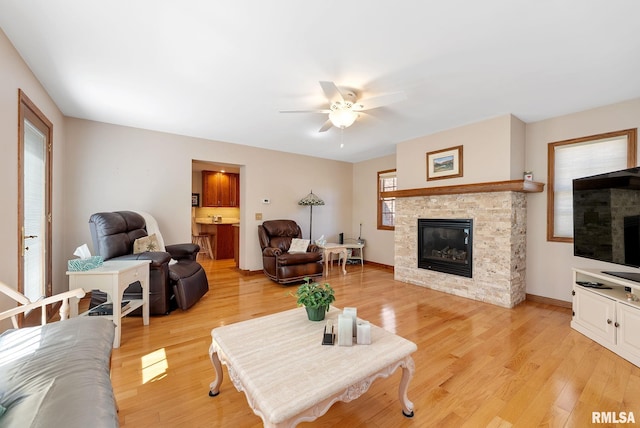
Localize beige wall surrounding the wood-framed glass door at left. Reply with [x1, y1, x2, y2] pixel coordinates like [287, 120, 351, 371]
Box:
[0, 30, 67, 310]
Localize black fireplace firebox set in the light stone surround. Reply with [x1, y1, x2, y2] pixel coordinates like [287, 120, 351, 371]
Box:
[418, 218, 473, 278]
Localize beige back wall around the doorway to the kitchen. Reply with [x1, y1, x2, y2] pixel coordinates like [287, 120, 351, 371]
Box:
[64, 118, 353, 270]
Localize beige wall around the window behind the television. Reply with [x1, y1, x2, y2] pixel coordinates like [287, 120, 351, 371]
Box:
[526, 98, 640, 301]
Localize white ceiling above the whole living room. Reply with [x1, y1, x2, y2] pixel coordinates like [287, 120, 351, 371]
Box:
[0, 0, 640, 162]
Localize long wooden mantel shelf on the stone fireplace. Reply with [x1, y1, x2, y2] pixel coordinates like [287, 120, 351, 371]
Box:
[380, 180, 544, 198]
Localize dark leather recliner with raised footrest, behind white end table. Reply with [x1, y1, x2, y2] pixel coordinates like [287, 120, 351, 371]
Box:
[89, 211, 209, 315]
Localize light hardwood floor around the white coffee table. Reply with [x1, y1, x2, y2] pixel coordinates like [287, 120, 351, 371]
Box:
[112, 260, 640, 427]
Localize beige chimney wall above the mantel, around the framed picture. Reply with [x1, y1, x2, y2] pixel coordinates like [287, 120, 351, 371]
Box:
[396, 115, 524, 189]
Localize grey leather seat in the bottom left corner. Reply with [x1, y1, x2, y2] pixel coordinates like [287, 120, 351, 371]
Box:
[0, 317, 118, 428]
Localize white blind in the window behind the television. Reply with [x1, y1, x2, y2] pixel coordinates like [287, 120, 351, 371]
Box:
[553, 136, 627, 238]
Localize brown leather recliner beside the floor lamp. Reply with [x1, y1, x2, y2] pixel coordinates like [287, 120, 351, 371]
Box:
[258, 220, 322, 284]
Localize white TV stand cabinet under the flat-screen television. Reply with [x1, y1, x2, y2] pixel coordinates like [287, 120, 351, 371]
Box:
[571, 268, 640, 367]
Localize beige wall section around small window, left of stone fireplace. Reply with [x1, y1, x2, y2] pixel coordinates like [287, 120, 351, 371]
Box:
[352, 155, 396, 266]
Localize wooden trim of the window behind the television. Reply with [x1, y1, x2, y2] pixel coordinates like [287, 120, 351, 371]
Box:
[547, 128, 637, 243]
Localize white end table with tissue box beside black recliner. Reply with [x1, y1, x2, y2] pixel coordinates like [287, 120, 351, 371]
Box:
[67, 260, 151, 348]
